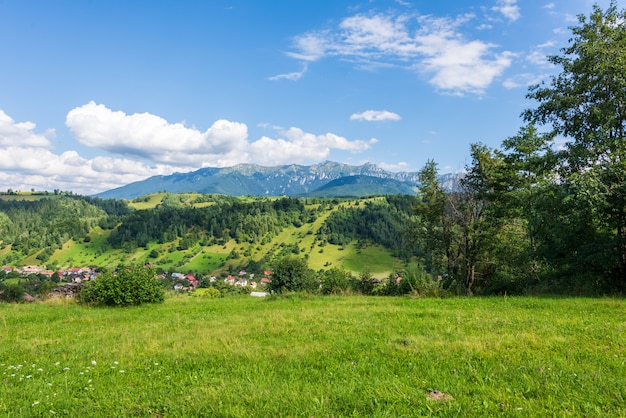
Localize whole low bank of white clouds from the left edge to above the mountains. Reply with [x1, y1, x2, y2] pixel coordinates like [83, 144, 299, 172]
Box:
[0, 106, 376, 194]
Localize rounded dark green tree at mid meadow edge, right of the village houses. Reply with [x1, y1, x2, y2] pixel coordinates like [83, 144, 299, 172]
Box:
[269, 256, 315, 293]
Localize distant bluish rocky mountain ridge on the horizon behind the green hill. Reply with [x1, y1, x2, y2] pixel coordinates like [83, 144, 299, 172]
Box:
[96, 161, 428, 199]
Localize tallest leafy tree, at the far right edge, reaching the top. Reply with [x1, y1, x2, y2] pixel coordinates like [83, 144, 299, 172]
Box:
[523, 1, 626, 290]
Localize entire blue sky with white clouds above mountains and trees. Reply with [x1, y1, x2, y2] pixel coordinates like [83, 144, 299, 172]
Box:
[0, 0, 623, 194]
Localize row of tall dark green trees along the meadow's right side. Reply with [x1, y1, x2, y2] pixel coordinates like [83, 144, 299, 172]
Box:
[410, 2, 626, 294]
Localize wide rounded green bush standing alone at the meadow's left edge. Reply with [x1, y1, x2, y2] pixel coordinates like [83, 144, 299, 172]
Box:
[79, 265, 165, 306]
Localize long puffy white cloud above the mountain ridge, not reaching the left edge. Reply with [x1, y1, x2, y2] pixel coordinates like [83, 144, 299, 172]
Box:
[66, 102, 371, 167]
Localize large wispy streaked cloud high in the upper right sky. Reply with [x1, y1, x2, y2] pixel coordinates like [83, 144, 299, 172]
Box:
[276, 10, 519, 94]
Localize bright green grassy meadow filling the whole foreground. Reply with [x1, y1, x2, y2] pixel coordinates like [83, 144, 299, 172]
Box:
[0, 295, 626, 417]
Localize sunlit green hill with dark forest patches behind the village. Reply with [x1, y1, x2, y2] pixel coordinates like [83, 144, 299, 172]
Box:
[0, 193, 415, 277]
